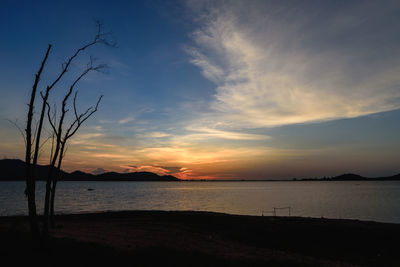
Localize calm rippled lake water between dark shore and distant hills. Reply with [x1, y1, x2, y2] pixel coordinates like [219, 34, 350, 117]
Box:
[0, 181, 400, 223]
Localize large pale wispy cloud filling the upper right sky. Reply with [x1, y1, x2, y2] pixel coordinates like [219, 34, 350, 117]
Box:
[186, 1, 400, 129]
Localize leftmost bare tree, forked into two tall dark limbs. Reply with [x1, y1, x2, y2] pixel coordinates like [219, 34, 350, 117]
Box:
[25, 21, 115, 237]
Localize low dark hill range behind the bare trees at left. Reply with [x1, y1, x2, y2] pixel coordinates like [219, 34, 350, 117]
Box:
[0, 159, 180, 181]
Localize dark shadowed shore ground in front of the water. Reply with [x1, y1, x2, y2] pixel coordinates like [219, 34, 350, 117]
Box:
[0, 211, 400, 266]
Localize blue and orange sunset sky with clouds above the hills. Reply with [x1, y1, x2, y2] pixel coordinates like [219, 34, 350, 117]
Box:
[0, 0, 400, 179]
